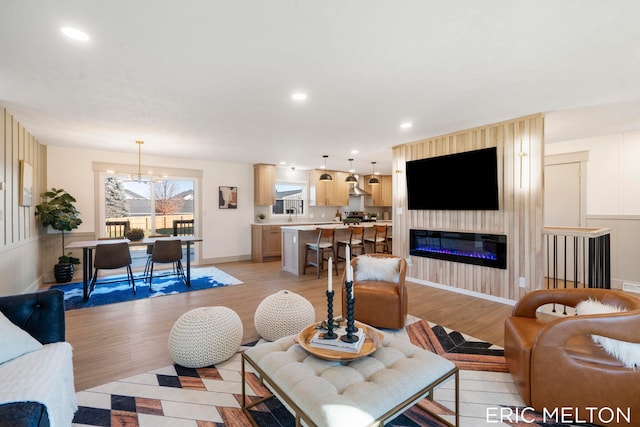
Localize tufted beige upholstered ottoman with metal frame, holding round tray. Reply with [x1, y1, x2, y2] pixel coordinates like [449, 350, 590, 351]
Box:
[242, 335, 459, 427]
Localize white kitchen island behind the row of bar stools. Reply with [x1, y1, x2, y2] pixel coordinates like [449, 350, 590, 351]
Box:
[280, 221, 391, 275]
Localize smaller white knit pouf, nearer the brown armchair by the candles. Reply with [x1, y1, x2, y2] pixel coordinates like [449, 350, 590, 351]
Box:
[253, 291, 316, 341]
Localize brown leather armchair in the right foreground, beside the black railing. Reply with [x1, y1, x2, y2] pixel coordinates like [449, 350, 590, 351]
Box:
[504, 289, 640, 425]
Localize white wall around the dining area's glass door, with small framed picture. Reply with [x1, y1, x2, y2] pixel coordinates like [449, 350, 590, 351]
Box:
[47, 147, 253, 263]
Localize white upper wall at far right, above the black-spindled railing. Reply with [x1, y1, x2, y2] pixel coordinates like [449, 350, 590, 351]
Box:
[545, 132, 640, 215]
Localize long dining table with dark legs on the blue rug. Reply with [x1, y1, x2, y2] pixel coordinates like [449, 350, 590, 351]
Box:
[65, 236, 202, 300]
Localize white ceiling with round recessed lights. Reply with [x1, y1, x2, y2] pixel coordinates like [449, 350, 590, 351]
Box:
[0, 0, 640, 173]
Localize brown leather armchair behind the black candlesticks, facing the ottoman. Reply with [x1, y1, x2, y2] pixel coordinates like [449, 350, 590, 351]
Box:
[342, 254, 408, 329]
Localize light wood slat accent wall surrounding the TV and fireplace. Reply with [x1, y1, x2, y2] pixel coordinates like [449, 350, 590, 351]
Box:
[393, 114, 544, 300]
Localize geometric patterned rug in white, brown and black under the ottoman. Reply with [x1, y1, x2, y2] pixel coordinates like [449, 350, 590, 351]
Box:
[73, 319, 584, 427]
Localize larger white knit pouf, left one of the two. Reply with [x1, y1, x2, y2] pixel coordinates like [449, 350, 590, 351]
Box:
[169, 307, 243, 368]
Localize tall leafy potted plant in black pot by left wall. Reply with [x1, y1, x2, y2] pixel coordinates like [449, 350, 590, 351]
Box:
[36, 188, 82, 283]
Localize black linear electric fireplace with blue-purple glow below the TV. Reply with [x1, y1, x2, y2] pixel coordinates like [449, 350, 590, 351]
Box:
[409, 229, 507, 269]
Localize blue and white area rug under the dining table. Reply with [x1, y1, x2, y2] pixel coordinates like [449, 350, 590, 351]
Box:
[51, 267, 242, 310]
